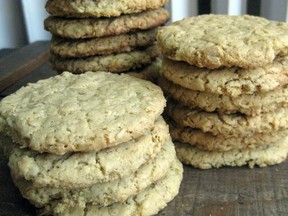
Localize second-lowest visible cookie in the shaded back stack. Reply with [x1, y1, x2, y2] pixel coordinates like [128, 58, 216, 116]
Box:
[50, 28, 158, 58]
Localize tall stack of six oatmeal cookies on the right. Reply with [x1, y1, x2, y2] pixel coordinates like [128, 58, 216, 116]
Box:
[157, 14, 288, 169]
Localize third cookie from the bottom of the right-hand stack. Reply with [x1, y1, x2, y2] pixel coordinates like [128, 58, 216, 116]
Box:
[167, 102, 288, 137]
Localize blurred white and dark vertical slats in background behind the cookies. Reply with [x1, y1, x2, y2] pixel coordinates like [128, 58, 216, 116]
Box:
[0, 0, 288, 49]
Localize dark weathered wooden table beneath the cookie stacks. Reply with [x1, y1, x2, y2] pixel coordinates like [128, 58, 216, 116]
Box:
[0, 42, 288, 216]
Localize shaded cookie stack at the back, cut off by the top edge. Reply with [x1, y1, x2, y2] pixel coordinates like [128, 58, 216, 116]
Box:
[44, 0, 169, 79]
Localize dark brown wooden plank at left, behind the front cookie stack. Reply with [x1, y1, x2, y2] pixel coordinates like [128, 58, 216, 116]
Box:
[0, 41, 49, 92]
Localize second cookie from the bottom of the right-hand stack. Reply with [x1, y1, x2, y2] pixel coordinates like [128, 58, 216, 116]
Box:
[169, 120, 288, 151]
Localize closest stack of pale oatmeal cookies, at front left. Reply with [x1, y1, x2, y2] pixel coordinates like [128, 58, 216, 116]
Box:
[0, 72, 183, 216]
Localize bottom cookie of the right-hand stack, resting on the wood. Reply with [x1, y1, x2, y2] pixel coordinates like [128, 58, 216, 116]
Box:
[175, 137, 288, 169]
